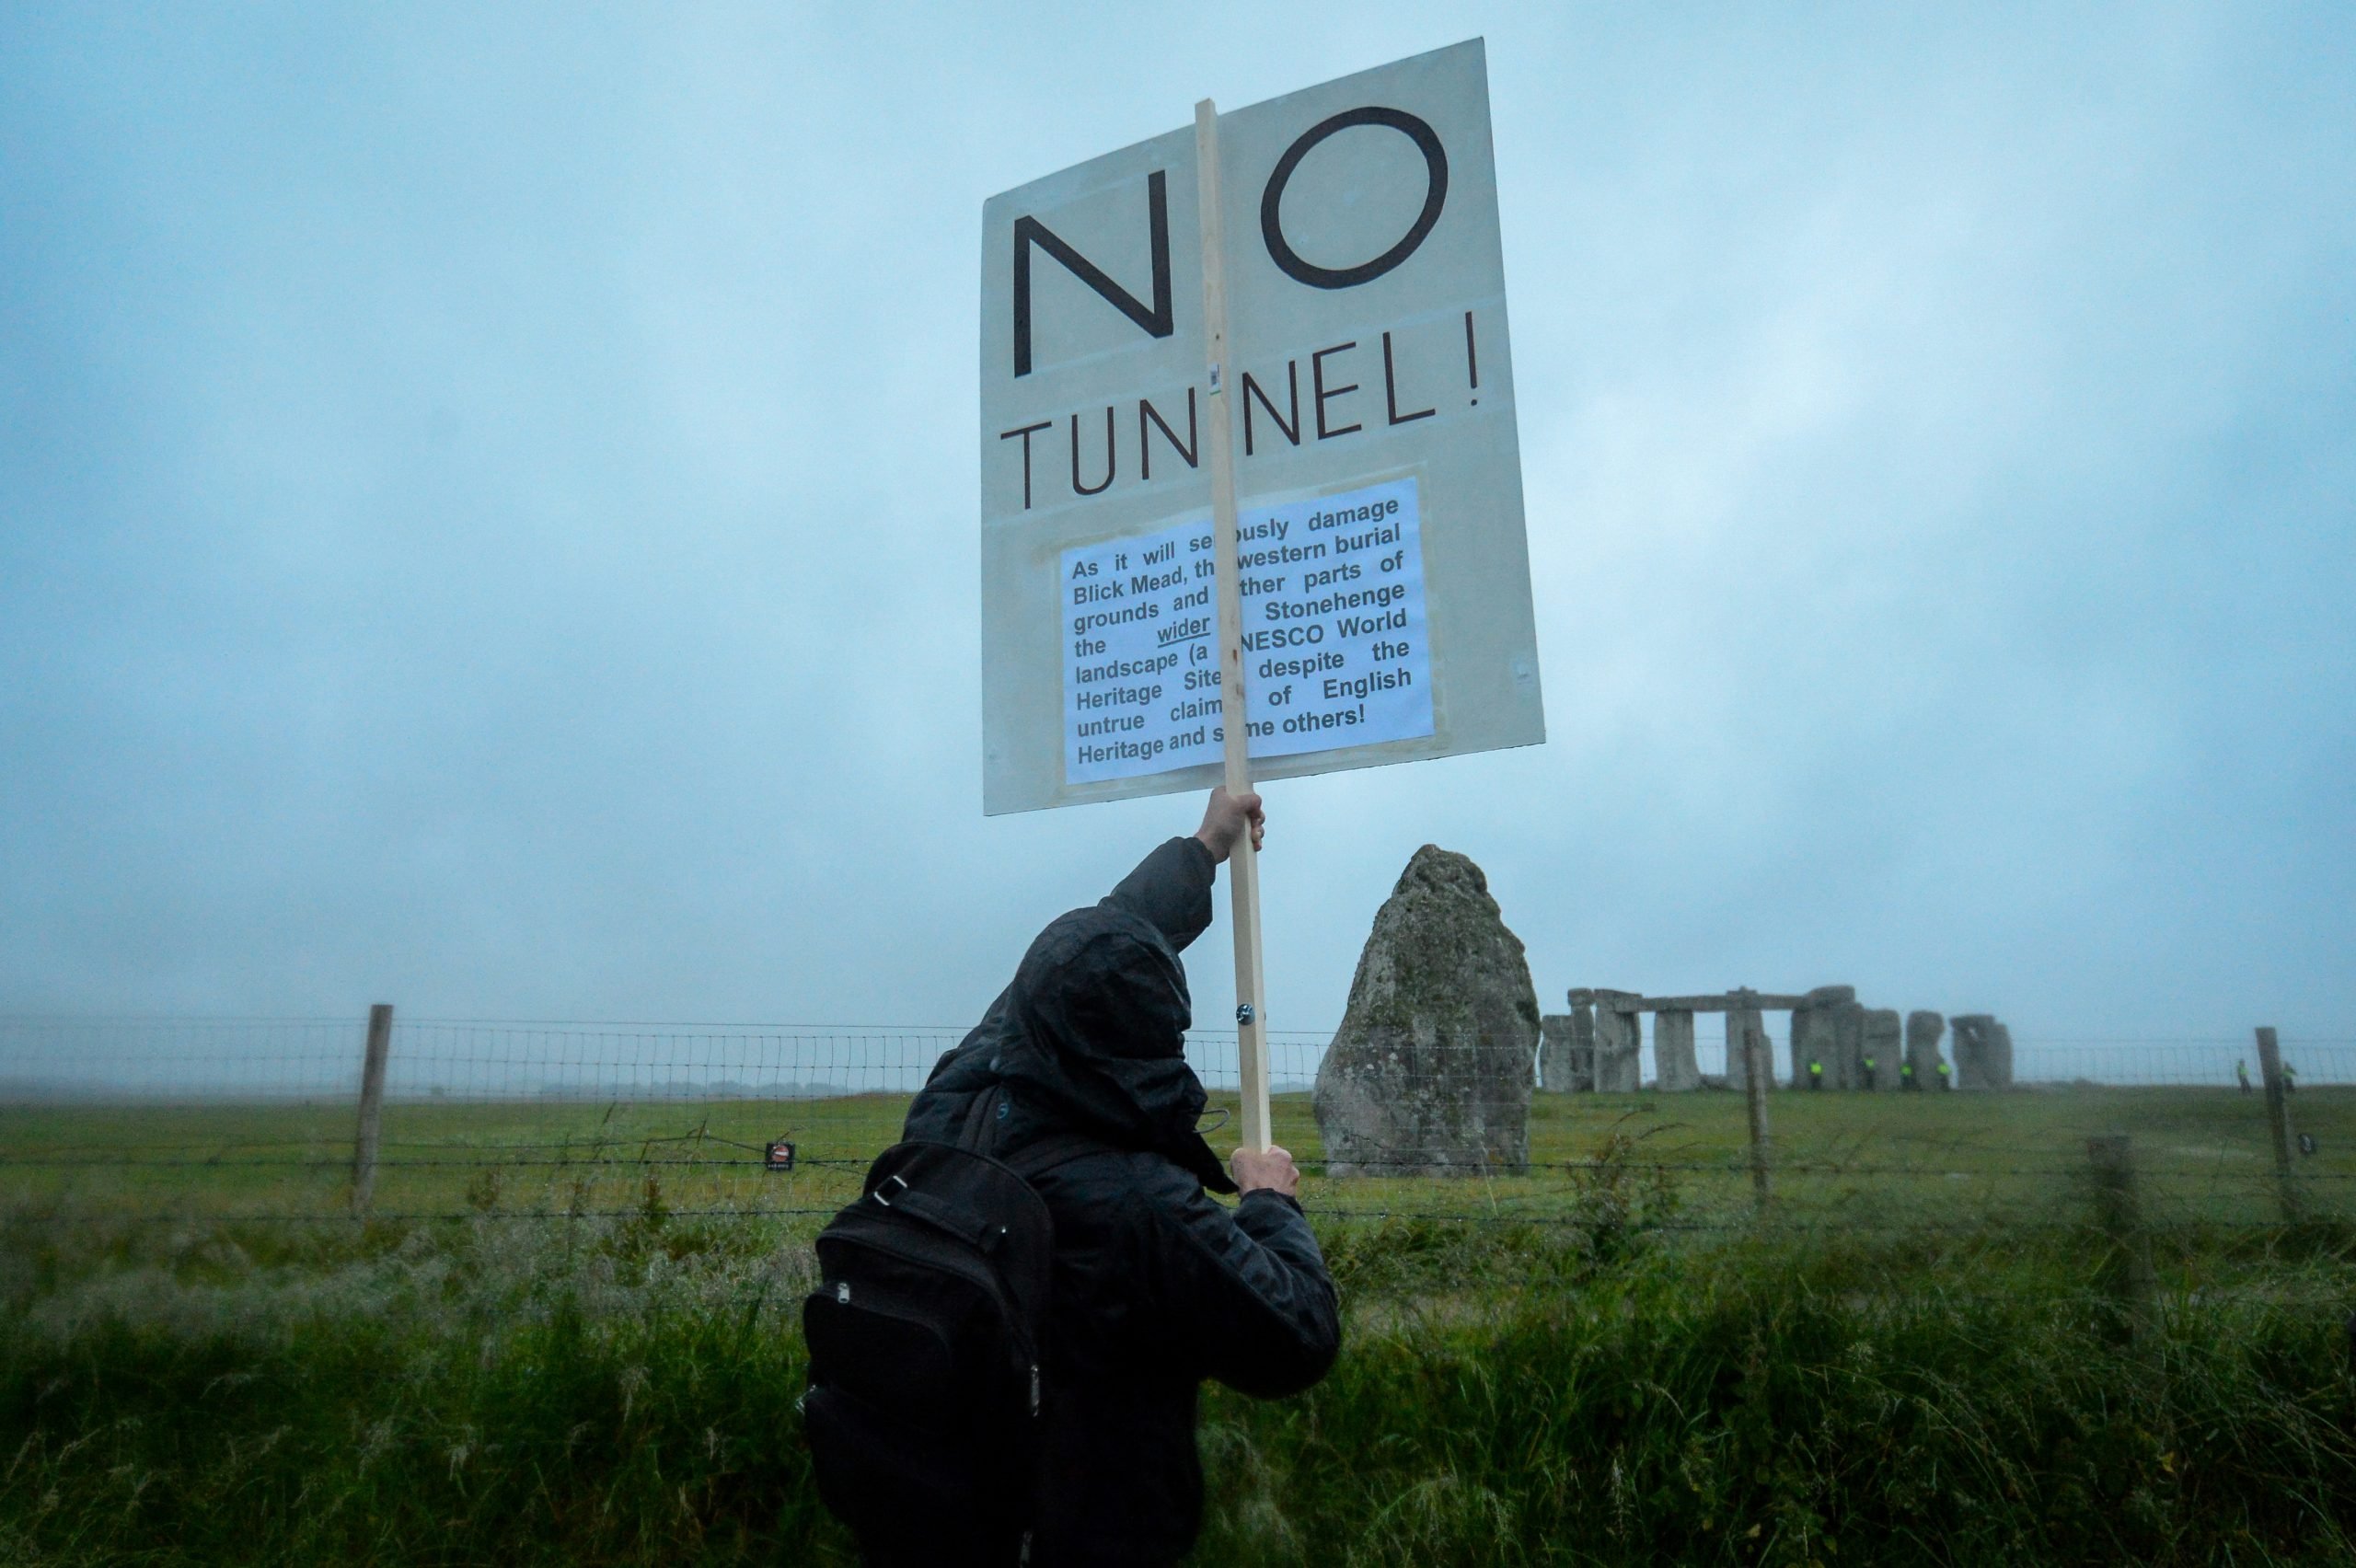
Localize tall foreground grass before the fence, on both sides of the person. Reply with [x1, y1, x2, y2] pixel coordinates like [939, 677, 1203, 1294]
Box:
[0, 1160, 2356, 1565]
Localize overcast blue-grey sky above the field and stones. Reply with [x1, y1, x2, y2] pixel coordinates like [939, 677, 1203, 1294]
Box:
[0, 5, 2356, 1038]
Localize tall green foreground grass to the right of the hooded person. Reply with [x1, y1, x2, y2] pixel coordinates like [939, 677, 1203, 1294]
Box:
[1199, 1234, 2356, 1563]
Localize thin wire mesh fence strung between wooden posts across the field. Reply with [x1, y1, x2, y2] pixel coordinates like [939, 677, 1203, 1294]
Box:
[0, 1017, 2356, 1234]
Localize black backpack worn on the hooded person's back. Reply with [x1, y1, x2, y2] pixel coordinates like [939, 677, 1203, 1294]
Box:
[801, 1090, 1103, 1563]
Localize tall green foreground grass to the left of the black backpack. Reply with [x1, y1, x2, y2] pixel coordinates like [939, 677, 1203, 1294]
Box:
[0, 1213, 834, 1563]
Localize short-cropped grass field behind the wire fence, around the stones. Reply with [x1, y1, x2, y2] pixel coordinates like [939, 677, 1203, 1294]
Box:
[0, 1088, 2356, 1227]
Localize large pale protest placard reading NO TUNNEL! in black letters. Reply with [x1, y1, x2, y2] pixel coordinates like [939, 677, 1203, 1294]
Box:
[980, 40, 1545, 813]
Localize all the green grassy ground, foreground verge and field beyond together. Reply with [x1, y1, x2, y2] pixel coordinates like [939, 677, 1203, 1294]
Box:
[0, 1088, 2356, 1565]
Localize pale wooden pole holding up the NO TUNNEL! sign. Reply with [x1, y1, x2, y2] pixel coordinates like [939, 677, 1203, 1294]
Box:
[1195, 98, 1267, 1149]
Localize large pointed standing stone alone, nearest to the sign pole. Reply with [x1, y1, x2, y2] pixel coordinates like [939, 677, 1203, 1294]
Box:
[1314, 846, 1539, 1175]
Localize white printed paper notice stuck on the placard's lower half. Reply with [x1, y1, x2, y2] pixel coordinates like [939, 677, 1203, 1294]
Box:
[1063, 478, 1432, 784]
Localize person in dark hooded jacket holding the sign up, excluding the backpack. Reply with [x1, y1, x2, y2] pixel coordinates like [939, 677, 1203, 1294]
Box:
[905, 789, 1341, 1568]
